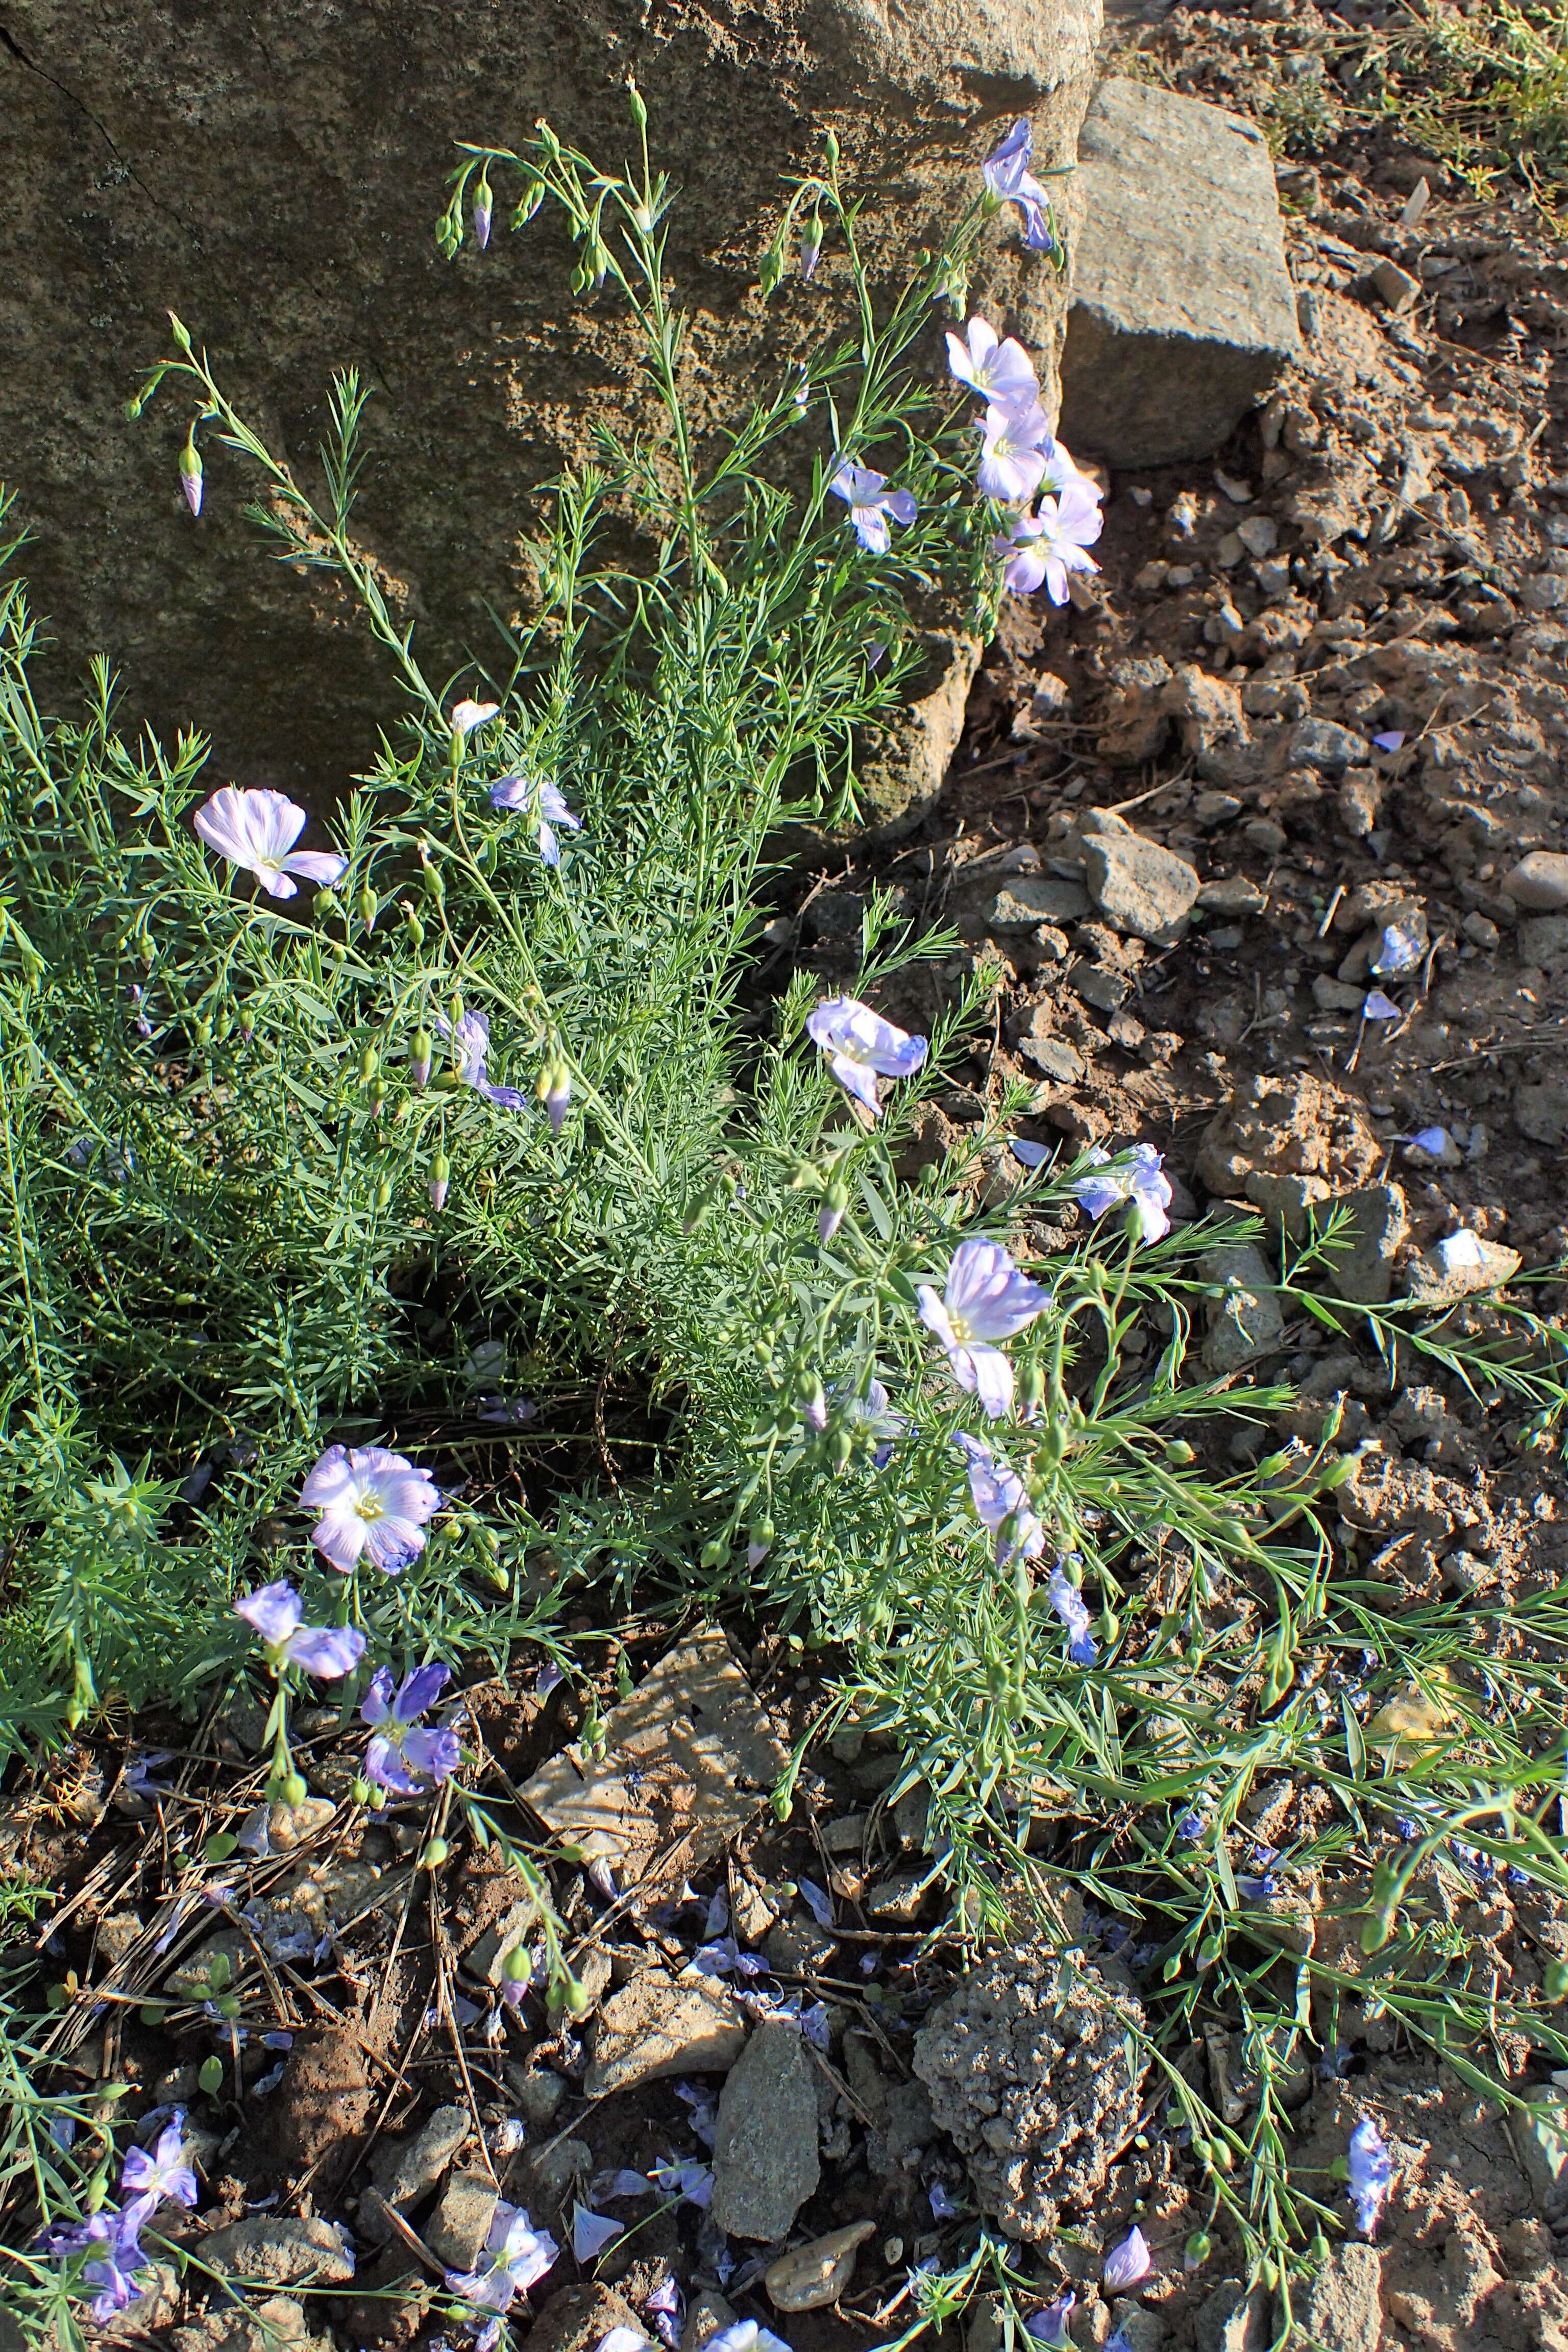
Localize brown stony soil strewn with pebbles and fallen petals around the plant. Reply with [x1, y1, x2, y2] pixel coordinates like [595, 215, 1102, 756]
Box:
[0, 14, 1568, 2352]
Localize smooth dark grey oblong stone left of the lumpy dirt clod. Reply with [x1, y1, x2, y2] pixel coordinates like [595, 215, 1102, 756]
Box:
[713, 2025, 820, 2241]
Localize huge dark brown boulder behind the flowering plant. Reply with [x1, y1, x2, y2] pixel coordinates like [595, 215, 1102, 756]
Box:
[0, 0, 1100, 818]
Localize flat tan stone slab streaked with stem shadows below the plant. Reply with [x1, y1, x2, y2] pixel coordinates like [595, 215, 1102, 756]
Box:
[522, 1632, 790, 1896]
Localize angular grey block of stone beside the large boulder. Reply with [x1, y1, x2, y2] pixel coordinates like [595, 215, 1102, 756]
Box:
[1063, 78, 1300, 465]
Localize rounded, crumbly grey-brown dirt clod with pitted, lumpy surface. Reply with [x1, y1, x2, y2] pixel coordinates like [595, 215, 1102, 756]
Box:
[915, 1943, 1145, 2241]
